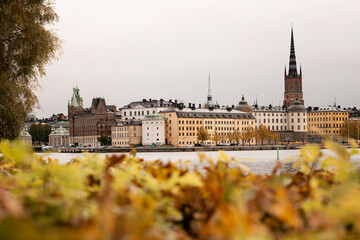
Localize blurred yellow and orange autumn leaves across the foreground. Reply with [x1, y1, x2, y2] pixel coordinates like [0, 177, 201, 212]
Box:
[0, 141, 360, 239]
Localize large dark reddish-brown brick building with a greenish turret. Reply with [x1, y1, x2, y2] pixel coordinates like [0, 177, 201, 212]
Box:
[68, 87, 116, 147]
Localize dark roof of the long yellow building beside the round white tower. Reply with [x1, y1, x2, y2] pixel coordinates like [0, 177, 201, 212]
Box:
[160, 108, 255, 119]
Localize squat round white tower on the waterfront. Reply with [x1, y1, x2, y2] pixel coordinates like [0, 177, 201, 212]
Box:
[142, 114, 165, 146]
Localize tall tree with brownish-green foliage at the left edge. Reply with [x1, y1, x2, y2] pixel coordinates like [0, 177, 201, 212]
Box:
[0, 0, 60, 139]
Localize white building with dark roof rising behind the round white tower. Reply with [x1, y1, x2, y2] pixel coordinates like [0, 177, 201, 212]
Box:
[119, 98, 176, 120]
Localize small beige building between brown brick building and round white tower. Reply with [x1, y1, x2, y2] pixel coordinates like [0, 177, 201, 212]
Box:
[111, 120, 142, 147]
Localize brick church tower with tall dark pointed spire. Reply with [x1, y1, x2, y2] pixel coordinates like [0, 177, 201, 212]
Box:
[283, 27, 304, 107]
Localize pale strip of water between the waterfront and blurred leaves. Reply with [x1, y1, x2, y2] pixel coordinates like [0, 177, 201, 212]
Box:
[38, 149, 360, 174]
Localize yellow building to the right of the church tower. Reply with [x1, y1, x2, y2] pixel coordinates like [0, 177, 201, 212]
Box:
[307, 106, 349, 141]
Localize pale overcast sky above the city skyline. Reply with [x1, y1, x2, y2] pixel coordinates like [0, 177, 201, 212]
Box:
[36, 0, 360, 117]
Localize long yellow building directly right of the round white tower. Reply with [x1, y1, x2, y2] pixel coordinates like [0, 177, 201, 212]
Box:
[159, 108, 255, 146]
